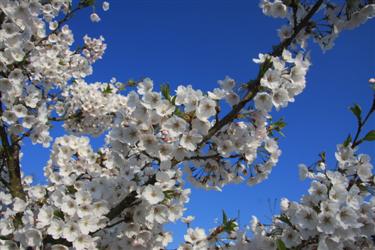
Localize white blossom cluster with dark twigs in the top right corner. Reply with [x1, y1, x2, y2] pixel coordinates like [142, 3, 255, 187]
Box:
[259, 0, 375, 50]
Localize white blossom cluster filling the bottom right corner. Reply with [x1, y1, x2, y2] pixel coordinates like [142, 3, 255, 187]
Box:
[180, 144, 375, 250]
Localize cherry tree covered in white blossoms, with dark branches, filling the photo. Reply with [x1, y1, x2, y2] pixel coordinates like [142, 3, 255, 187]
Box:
[0, 0, 375, 249]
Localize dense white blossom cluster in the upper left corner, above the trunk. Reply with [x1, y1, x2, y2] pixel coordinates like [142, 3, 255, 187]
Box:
[0, 0, 106, 147]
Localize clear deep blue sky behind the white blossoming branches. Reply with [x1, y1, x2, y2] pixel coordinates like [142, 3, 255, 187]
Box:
[22, 0, 375, 247]
